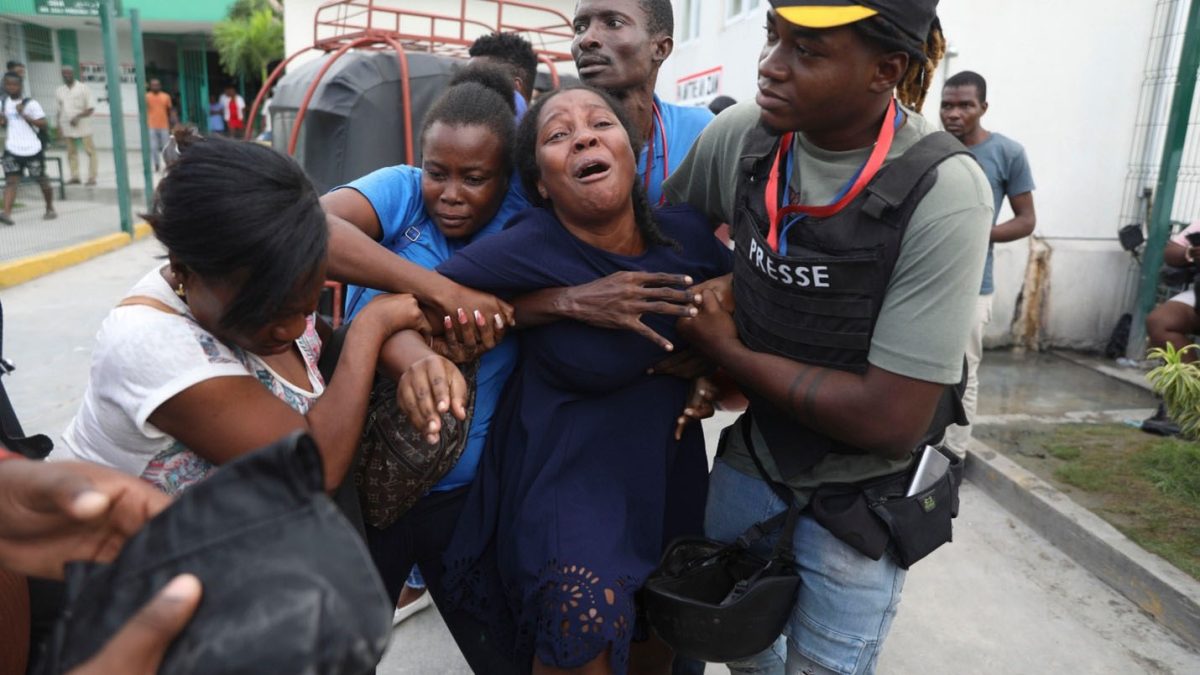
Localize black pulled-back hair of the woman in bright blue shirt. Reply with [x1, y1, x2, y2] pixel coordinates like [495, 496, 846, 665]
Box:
[421, 64, 516, 173]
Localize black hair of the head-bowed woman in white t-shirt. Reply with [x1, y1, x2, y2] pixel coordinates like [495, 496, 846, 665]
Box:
[144, 138, 329, 330]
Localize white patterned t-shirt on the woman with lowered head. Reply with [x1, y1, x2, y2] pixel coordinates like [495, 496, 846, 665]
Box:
[56, 268, 324, 494]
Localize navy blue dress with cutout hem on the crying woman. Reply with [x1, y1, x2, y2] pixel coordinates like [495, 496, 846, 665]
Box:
[438, 207, 730, 673]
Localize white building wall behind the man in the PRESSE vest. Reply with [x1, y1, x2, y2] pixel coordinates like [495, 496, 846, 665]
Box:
[658, 0, 1161, 347]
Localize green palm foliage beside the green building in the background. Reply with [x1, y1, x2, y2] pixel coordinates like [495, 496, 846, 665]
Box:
[212, 0, 283, 82]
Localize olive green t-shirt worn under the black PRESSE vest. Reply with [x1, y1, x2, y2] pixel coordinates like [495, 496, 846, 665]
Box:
[664, 101, 992, 503]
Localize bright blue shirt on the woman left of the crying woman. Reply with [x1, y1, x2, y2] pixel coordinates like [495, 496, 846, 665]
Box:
[335, 165, 529, 492]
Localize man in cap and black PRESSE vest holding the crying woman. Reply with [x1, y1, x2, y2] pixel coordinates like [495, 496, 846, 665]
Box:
[665, 0, 992, 674]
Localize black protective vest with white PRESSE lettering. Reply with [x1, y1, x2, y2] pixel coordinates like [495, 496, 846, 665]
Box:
[732, 124, 968, 480]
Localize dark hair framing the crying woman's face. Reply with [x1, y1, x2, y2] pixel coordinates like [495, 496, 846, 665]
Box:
[512, 84, 679, 247]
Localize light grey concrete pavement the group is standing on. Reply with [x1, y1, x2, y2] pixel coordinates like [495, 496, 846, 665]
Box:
[0, 240, 1200, 675]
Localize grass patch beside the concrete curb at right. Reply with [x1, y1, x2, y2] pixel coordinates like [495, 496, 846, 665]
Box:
[979, 424, 1200, 579]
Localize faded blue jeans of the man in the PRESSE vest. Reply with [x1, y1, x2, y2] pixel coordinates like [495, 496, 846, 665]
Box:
[704, 459, 905, 675]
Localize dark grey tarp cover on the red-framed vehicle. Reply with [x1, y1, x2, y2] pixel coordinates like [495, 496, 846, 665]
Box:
[271, 50, 464, 192]
